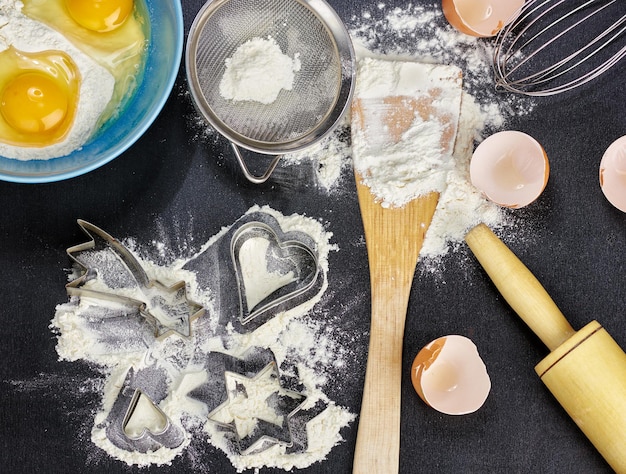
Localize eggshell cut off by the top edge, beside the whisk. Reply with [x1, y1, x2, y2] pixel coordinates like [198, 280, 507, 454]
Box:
[441, 0, 524, 37]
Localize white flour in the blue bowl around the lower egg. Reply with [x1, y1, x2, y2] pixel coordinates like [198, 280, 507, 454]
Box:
[0, 0, 115, 160]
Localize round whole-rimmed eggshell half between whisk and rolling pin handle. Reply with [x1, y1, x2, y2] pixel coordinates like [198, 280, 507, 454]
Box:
[470, 130, 550, 208]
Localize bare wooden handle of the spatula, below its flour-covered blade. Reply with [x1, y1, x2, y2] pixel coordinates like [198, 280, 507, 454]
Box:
[352, 184, 439, 474]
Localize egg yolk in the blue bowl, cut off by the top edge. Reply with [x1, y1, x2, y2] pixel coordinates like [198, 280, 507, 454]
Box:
[65, 0, 133, 32]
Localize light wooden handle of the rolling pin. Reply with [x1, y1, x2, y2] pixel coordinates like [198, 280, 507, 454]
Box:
[465, 224, 575, 351]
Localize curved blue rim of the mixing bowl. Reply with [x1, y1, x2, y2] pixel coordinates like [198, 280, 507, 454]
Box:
[0, 0, 184, 184]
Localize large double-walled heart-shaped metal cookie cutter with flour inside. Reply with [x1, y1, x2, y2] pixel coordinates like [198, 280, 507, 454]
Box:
[230, 222, 319, 324]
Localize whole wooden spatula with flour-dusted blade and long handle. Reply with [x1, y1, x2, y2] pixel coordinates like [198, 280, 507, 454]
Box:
[352, 60, 462, 474]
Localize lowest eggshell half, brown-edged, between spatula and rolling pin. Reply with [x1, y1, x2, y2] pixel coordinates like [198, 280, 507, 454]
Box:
[411, 335, 491, 415]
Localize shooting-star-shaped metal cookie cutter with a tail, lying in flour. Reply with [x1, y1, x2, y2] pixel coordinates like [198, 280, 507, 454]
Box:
[66, 219, 205, 338]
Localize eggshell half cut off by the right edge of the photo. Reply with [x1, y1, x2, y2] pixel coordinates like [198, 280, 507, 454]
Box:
[600, 136, 626, 212]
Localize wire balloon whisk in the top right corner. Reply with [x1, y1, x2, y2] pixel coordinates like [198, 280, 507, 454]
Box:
[493, 0, 626, 96]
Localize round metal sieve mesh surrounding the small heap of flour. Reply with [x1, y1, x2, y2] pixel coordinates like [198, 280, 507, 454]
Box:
[195, 0, 343, 147]
